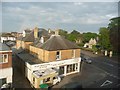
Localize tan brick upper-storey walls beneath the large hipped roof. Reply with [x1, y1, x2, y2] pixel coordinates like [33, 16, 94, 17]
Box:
[30, 46, 80, 62]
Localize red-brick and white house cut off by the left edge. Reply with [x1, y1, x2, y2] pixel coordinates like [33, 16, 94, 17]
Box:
[0, 43, 13, 87]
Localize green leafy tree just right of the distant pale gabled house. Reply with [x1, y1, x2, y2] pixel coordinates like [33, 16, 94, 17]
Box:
[99, 27, 111, 50]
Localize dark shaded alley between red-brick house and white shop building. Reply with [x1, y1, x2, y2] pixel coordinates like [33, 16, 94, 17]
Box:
[12, 55, 33, 90]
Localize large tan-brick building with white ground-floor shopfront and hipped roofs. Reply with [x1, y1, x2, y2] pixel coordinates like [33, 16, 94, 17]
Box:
[16, 28, 81, 88]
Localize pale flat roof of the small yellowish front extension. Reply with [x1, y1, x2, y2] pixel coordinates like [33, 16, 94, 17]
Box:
[33, 68, 57, 78]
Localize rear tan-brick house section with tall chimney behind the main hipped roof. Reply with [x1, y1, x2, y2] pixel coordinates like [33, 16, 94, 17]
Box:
[16, 27, 50, 50]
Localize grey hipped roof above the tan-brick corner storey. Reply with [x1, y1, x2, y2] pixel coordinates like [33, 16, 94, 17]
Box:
[40, 35, 79, 51]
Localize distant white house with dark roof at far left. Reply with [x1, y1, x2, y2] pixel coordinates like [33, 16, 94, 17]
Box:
[1, 33, 16, 43]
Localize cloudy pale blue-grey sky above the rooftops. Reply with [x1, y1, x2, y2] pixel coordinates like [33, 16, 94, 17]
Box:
[0, 2, 118, 33]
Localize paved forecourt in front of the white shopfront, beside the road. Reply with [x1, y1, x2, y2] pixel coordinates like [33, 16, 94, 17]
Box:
[53, 62, 107, 88]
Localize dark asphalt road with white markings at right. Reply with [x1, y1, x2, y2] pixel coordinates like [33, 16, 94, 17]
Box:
[82, 51, 120, 88]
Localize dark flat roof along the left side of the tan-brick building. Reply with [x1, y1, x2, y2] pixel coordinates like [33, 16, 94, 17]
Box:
[16, 50, 44, 65]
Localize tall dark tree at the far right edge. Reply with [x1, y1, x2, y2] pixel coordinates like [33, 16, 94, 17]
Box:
[108, 17, 120, 53]
